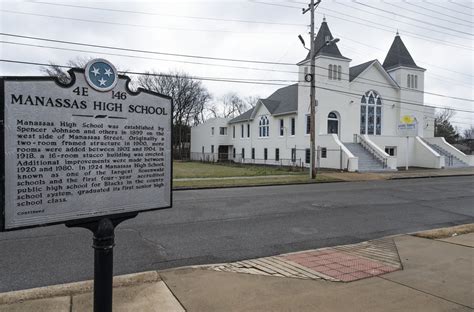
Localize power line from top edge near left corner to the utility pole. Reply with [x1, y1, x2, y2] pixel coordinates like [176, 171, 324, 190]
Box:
[27, 1, 307, 26]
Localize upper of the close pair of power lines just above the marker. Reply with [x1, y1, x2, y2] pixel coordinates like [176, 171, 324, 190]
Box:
[0, 32, 295, 66]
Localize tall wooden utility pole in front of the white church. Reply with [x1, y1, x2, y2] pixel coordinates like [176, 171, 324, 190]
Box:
[303, 0, 321, 179]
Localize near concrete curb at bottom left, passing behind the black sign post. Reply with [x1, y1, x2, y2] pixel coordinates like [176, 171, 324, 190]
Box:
[0, 271, 161, 305]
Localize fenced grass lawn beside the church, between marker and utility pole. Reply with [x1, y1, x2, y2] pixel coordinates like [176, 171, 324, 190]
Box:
[173, 161, 305, 179]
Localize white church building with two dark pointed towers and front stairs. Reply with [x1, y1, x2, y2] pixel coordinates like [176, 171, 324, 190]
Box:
[191, 21, 474, 171]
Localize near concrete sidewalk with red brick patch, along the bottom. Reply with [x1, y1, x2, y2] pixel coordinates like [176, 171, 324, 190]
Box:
[0, 233, 474, 312]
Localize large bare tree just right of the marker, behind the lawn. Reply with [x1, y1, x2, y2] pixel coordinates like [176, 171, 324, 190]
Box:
[137, 71, 211, 155]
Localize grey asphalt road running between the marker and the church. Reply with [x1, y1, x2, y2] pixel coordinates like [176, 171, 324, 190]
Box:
[0, 176, 474, 292]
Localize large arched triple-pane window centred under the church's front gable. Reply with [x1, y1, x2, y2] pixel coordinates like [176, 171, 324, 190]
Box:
[360, 91, 382, 135]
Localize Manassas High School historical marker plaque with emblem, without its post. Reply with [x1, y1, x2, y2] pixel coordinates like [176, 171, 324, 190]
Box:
[0, 59, 172, 230]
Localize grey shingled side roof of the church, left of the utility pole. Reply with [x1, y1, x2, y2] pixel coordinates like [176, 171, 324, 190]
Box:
[229, 83, 298, 123]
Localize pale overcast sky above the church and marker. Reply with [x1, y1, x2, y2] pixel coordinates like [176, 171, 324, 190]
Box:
[0, 0, 474, 129]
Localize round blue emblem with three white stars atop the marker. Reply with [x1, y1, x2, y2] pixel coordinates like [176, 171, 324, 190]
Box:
[85, 59, 118, 92]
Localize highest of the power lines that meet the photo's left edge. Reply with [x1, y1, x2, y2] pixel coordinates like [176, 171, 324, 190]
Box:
[0, 10, 298, 35]
